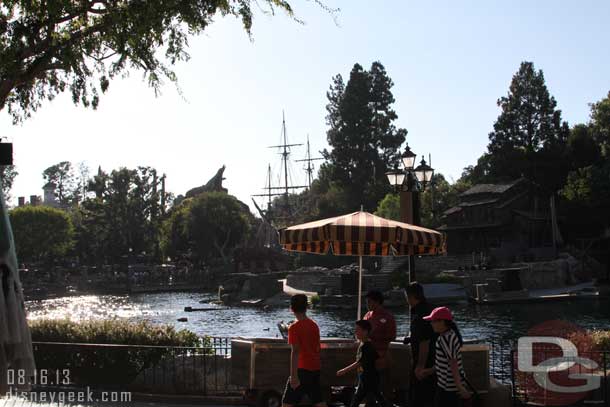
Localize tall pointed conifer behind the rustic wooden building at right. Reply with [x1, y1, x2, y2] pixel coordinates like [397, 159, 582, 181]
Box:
[480, 62, 569, 192]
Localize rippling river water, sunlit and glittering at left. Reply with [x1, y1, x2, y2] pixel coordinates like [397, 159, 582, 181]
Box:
[26, 293, 610, 341]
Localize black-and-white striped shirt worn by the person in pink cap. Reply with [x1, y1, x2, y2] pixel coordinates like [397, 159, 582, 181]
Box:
[434, 329, 464, 392]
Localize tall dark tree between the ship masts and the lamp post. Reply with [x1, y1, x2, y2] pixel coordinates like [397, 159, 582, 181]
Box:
[320, 62, 407, 210]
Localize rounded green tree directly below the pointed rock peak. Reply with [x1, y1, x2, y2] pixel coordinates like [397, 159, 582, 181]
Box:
[164, 192, 252, 264]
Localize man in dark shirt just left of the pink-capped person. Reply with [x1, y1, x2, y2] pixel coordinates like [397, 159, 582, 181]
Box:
[407, 282, 436, 407]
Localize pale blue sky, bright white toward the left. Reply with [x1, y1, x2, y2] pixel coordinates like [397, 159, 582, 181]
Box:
[0, 0, 610, 210]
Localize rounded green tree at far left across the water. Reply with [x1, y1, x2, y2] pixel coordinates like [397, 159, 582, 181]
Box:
[10, 206, 74, 261]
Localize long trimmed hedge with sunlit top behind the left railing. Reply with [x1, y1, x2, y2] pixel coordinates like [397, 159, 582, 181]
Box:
[30, 319, 211, 387]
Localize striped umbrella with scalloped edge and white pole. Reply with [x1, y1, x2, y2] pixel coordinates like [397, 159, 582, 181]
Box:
[280, 211, 446, 318]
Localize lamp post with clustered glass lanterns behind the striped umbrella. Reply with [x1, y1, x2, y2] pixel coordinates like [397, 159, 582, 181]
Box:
[386, 144, 434, 282]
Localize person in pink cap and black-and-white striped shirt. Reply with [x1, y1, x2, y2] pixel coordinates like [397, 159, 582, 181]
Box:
[424, 307, 471, 407]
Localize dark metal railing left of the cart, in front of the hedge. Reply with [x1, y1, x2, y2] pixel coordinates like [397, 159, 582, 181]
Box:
[33, 338, 242, 396]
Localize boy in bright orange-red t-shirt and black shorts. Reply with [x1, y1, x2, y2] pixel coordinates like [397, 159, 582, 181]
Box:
[282, 294, 326, 407]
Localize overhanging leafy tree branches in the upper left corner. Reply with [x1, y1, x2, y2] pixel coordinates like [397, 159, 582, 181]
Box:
[0, 0, 308, 122]
